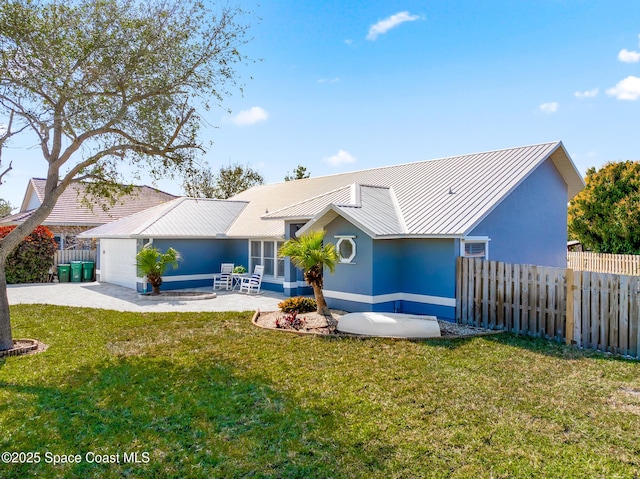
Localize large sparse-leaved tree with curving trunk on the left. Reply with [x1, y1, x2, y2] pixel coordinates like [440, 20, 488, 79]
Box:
[0, 0, 248, 350]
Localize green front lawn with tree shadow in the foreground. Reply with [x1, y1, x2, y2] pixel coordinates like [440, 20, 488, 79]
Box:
[0, 306, 640, 479]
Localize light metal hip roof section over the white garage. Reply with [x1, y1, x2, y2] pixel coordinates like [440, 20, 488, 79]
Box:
[78, 197, 247, 238]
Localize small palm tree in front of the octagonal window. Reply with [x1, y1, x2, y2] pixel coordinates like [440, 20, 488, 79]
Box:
[278, 231, 338, 318]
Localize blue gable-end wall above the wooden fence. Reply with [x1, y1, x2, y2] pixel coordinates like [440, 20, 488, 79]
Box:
[470, 159, 568, 267]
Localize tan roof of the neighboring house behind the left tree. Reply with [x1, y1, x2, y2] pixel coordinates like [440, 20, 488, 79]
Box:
[0, 178, 176, 226]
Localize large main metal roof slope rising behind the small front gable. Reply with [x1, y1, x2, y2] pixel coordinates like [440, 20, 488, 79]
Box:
[228, 141, 584, 237]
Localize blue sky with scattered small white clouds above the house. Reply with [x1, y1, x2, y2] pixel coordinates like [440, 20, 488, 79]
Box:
[0, 0, 640, 206]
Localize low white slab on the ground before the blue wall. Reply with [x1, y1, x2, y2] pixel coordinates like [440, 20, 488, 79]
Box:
[338, 313, 440, 338]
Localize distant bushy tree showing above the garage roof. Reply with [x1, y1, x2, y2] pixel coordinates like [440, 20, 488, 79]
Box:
[182, 164, 264, 199]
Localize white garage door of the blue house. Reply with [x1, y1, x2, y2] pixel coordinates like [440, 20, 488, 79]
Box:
[100, 239, 137, 289]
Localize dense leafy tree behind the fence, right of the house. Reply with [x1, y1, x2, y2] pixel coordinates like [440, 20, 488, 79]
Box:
[568, 161, 640, 254]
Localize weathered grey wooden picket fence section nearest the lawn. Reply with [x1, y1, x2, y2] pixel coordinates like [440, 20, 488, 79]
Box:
[456, 258, 640, 358]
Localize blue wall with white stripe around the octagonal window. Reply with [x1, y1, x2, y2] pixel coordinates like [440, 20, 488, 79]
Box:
[324, 218, 458, 319]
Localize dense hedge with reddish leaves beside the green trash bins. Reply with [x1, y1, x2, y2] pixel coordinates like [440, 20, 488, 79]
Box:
[0, 226, 56, 284]
